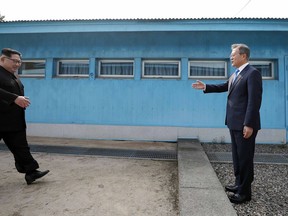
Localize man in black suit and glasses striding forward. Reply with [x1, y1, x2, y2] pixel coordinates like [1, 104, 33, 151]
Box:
[0, 48, 49, 185]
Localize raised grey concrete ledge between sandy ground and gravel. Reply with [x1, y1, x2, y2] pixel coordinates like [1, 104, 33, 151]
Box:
[178, 139, 237, 216]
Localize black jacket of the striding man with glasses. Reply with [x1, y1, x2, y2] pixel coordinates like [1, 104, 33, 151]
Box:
[0, 66, 26, 132]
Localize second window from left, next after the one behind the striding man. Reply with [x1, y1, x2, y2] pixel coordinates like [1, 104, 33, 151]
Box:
[57, 59, 89, 77]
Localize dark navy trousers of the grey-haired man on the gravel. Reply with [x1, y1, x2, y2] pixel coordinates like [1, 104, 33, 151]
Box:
[230, 130, 258, 196]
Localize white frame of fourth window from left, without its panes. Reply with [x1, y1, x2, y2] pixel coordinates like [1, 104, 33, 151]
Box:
[142, 59, 181, 79]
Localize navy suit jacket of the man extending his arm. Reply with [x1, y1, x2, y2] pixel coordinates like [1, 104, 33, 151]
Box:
[204, 65, 263, 130]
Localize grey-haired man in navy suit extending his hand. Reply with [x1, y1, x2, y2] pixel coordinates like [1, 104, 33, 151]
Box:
[192, 44, 262, 204]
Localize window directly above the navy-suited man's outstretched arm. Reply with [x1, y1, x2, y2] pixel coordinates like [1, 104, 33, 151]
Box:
[188, 61, 227, 78]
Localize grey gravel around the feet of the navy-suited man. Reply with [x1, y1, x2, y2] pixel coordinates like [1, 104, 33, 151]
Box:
[202, 144, 288, 216]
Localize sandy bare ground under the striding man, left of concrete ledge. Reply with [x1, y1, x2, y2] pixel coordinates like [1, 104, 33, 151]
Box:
[0, 138, 179, 216]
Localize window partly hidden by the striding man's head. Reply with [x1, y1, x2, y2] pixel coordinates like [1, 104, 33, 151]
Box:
[18, 60, 46, 77]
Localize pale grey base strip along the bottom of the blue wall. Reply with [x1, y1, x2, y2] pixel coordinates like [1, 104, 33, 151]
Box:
[27, 123, 287, 144]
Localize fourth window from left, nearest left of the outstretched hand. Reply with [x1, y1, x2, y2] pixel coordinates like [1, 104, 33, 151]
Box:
[142, 60, 180, 78]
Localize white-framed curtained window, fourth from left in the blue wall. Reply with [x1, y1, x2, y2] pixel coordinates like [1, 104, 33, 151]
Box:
[144, 61, 179, 77]
